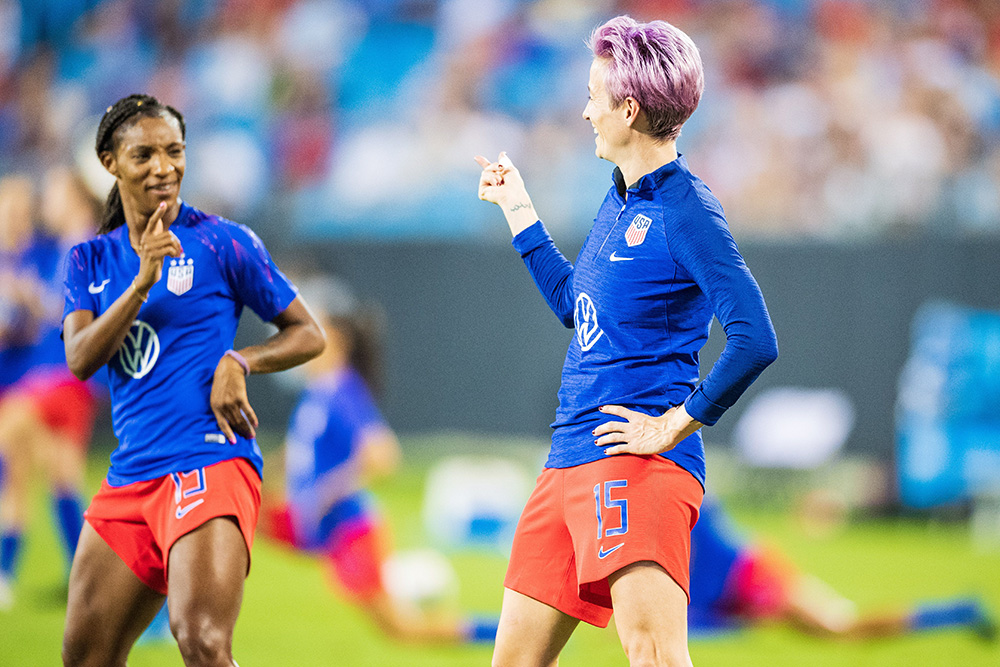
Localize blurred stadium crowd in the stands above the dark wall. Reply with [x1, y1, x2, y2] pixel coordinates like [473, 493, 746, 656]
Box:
[0, 0, 1000, 238]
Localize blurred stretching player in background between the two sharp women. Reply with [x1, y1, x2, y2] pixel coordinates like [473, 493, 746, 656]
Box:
[266, 278, 497, 642]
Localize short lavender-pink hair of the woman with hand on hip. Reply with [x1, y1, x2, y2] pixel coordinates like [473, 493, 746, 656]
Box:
[589, 16, 705, 140]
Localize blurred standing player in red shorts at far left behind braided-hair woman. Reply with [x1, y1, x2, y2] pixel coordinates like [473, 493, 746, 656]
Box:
[0, 167, 99, 607]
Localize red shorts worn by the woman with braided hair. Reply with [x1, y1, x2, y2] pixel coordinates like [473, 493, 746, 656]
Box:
[83, 459, 260, 595]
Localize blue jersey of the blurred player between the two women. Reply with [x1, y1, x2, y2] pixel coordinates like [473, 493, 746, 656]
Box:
[285, 368, 388, 548]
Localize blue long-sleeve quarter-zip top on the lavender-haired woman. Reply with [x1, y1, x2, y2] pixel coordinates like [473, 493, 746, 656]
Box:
[513, 156, 778, 485]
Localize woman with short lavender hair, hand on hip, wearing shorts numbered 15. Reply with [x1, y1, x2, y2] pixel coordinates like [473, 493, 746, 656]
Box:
[476, 16, 777, 665]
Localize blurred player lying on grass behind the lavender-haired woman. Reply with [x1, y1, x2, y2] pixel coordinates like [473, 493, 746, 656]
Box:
[688, 496, 997, 640]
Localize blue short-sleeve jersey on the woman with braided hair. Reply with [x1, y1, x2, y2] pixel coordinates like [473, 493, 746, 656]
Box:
[63, 203, 297, 486]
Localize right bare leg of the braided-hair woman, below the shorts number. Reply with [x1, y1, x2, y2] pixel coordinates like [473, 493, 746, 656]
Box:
[167, 517, 250, 667]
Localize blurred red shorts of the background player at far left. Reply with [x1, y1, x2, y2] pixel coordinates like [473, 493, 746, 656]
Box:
[18, 370, 96, 449]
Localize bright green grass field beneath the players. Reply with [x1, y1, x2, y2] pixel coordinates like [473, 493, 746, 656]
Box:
[0, 442, 1000, 667]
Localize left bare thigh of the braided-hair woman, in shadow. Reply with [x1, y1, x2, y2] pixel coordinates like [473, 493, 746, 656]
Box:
[62, 524, 163, 667]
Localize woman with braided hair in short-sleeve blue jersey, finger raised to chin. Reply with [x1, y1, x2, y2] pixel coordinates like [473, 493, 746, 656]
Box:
[63, 95, 323, 666]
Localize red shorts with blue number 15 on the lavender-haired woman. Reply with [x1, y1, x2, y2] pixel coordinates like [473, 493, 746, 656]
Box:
[504, 455, 704, 628]
